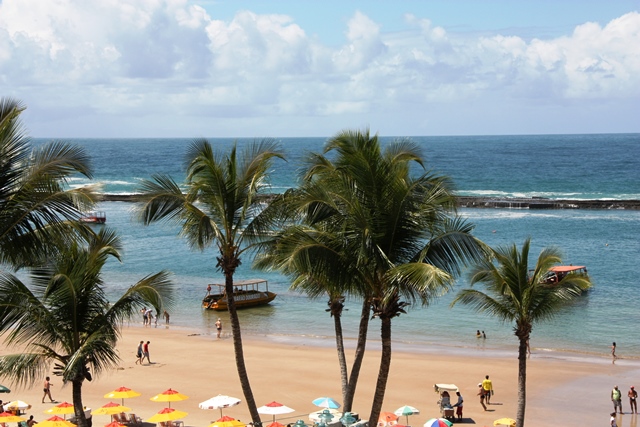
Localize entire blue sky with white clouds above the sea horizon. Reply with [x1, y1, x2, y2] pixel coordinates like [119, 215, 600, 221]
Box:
[0, 0, 640, 138]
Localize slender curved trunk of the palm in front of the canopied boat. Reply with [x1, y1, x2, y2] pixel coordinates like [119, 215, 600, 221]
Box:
[224, 272, 261, 425]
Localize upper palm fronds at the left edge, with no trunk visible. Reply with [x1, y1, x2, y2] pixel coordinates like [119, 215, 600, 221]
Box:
[0, 98, 96, 268]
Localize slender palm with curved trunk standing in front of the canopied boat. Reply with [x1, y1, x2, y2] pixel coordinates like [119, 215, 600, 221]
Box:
[140, 139, 283, 423]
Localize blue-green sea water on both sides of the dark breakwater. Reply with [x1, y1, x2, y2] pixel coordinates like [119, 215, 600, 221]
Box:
[35, 134, 640, 357]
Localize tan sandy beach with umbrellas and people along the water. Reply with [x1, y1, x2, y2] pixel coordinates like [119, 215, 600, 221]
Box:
[0, 325, 640, 427]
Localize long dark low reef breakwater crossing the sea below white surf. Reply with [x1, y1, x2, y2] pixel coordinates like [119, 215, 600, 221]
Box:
[100, 194, 640, 210]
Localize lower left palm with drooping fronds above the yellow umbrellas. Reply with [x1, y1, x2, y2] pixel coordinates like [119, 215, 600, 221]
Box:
[0, 229, 172, 427]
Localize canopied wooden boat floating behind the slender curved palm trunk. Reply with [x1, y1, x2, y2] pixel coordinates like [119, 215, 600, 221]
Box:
[202, 279, 276, 311]
